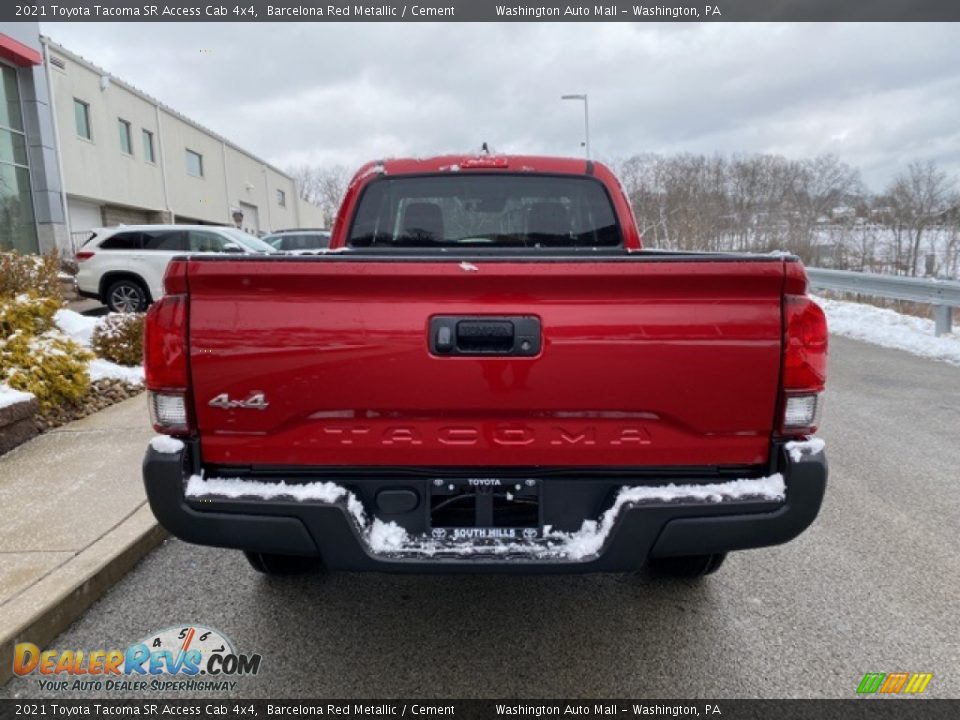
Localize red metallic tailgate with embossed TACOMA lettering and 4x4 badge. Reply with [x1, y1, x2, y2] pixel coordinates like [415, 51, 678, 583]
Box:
[188, 254, 785, 468]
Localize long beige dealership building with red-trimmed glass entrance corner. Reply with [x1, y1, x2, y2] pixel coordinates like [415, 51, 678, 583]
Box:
[0, 23, 323, 252]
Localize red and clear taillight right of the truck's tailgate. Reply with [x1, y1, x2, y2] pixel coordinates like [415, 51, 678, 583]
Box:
[781, 295, 827, 435]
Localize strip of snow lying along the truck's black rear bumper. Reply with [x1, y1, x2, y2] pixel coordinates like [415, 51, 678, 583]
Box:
[186, 472, 784, 560]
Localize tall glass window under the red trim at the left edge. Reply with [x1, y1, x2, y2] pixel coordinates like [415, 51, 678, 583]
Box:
[0, 64, 39, 253]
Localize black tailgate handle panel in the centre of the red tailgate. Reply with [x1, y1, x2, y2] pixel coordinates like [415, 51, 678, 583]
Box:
[429, 315, 541, 357]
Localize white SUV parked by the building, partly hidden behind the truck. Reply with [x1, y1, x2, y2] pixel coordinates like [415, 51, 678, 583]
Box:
[76, 225, 277, 312]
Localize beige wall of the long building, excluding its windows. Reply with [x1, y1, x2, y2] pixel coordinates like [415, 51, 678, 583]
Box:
[49, 44, 323, 231]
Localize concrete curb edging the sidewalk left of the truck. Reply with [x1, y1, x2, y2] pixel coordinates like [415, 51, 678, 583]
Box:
[0, 502, 167, 686]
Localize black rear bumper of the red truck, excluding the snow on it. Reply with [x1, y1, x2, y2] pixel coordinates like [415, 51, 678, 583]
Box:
[143, 445, 827, 573]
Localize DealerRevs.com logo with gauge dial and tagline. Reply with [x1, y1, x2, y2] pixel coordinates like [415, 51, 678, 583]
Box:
[13, 625, 262, 692]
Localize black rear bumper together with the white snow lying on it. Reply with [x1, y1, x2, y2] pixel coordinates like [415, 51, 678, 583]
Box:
[143, 441, 827, 574]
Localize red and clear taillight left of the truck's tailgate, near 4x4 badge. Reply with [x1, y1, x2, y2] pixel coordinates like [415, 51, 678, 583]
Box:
[143, 295, 192, 435]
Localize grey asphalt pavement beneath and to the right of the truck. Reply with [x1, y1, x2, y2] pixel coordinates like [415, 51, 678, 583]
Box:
[0, 338, 960, 699]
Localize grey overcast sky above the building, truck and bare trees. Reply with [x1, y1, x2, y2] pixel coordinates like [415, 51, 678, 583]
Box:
[42, 23, 960, 190]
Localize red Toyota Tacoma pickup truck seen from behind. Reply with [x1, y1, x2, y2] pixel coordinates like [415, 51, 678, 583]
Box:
[143, 156, 827, 576]
